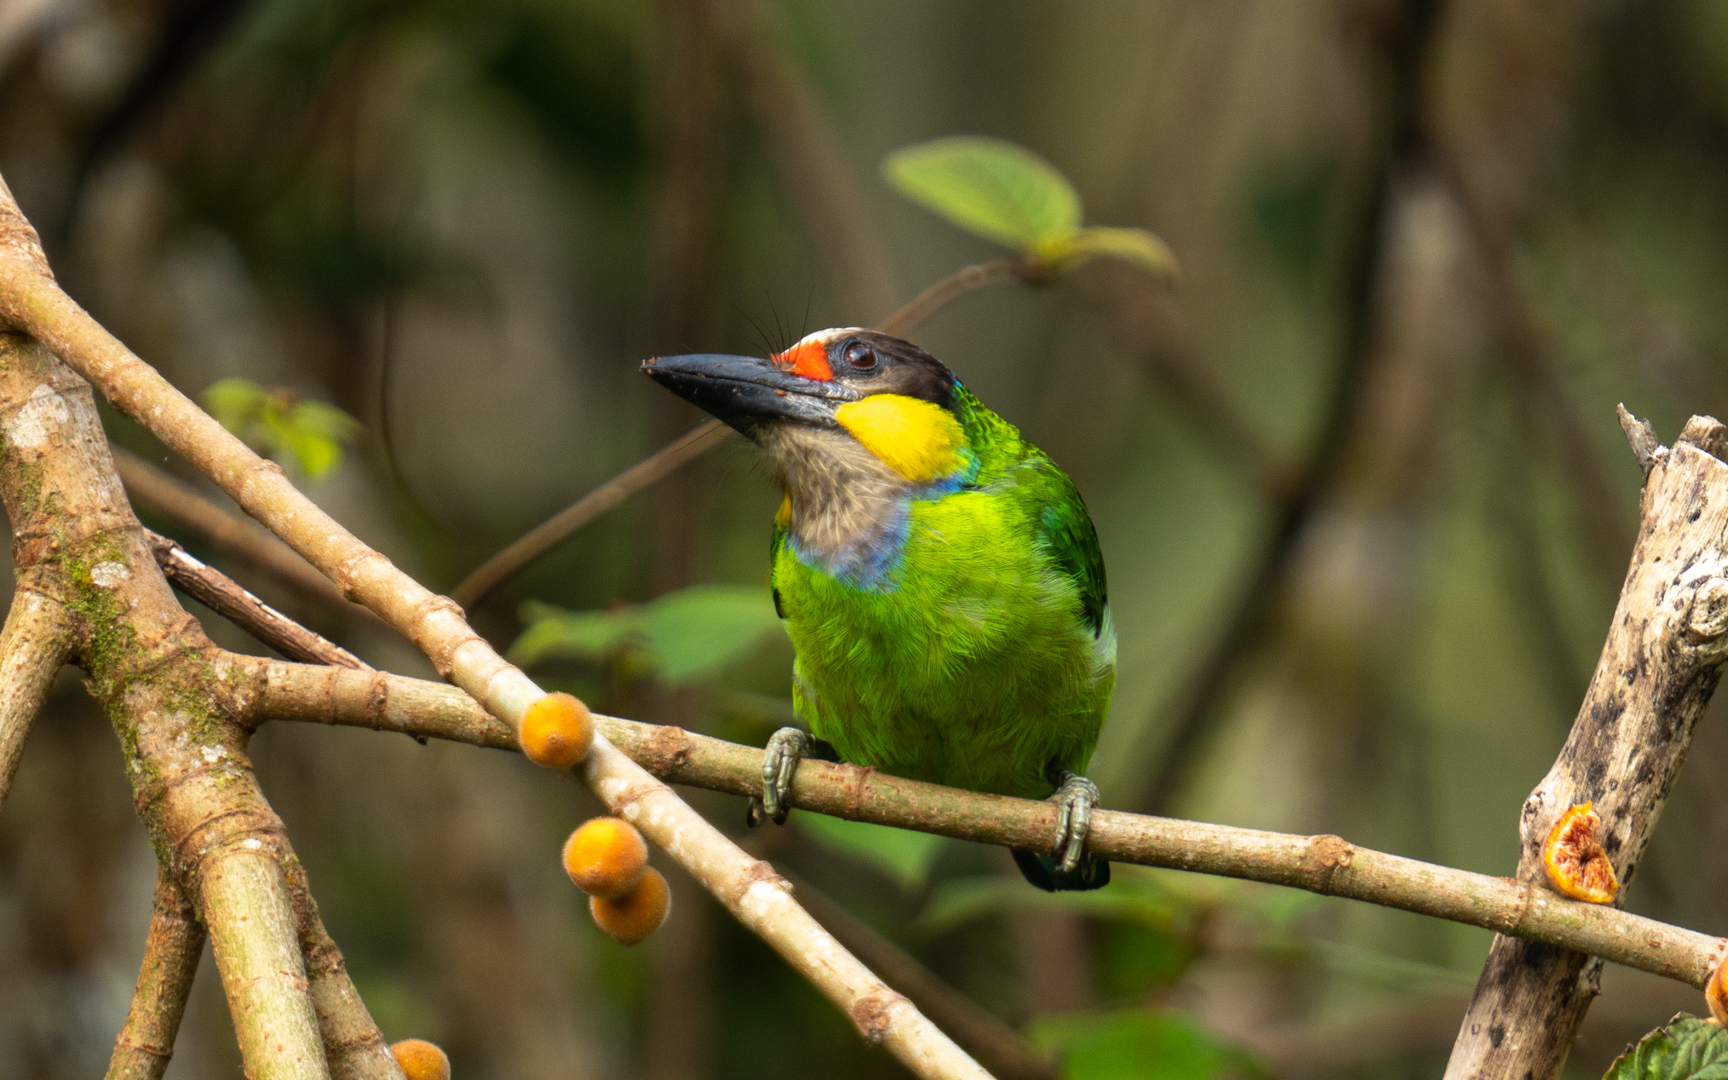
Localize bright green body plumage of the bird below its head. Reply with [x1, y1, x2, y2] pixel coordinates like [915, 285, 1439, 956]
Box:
[772, 391, 1116, 797]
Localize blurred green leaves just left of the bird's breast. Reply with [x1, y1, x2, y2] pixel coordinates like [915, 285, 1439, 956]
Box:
[510, 586, 781, 683]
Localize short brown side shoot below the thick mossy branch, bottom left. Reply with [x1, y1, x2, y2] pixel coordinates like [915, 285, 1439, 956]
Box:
[105, 867, 204, 1080]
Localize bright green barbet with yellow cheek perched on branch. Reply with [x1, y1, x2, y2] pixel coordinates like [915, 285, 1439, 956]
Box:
[643, 328, 1116, 890]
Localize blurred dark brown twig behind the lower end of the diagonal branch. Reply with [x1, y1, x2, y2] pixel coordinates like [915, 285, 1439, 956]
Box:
[788, 874, 1058, 1080]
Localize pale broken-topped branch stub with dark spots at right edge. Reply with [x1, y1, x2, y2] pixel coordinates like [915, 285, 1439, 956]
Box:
[1446, 415, 1728, 1080]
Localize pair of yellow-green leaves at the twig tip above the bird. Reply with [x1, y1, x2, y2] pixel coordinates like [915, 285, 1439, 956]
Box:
[881, 135, 1177, 278]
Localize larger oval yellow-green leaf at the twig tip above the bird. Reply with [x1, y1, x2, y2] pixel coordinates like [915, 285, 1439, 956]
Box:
[881, 135, 1080, 256]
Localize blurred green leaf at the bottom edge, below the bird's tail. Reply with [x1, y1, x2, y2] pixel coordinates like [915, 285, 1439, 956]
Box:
[1030, 1009, 1265, 1080]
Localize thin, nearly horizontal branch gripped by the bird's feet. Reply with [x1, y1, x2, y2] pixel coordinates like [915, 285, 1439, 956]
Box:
[243, 655, 1728, 987]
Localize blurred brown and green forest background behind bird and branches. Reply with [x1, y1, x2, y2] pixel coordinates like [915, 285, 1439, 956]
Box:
[0, 0, 1728, 1080]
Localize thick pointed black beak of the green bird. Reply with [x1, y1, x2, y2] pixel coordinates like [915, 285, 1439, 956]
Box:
[643, 353, 862, 435]
